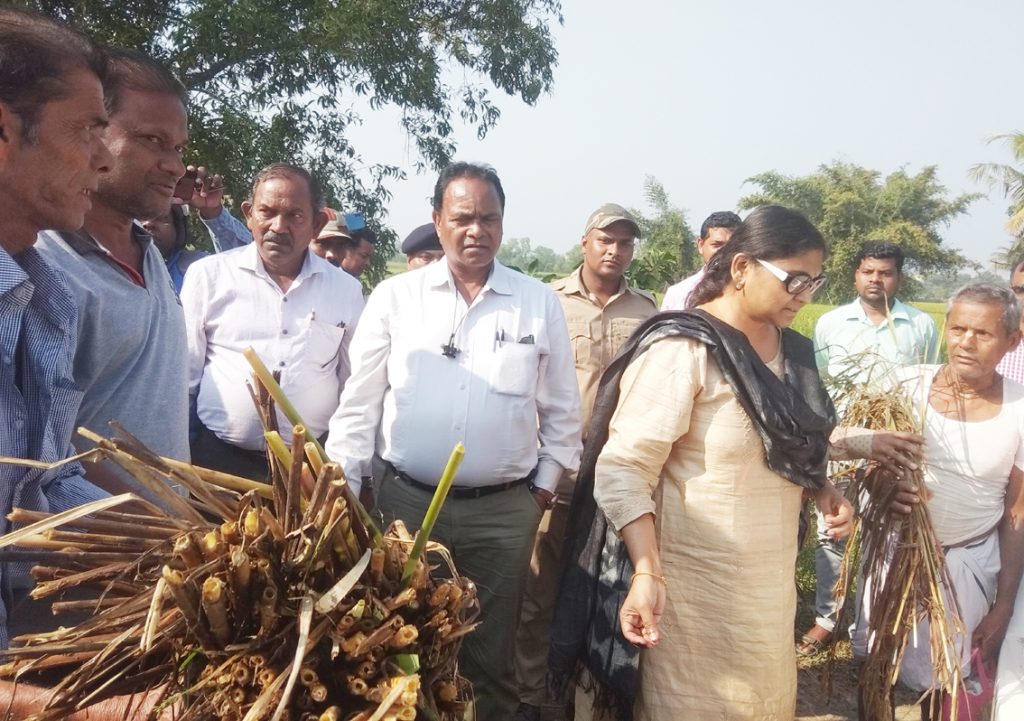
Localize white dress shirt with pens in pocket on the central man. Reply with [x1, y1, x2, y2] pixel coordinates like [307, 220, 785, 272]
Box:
[327, 261, 581, 492]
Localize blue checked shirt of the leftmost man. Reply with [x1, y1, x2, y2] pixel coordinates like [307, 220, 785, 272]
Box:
[0, 247, 106, 648]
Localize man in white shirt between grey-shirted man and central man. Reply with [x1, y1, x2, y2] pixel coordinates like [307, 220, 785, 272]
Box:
[181, 163, 362, 480]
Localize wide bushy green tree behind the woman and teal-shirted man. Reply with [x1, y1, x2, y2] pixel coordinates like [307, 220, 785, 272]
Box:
[739, 161, 979, 303]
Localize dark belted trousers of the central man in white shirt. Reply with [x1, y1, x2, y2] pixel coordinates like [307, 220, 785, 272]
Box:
[377, 470, 541, 721]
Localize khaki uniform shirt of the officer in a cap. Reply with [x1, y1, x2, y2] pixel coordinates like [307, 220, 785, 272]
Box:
[551, 266, 657, 499]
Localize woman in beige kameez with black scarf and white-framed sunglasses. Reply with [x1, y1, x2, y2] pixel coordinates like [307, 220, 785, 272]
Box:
[594, 206, 852, 721]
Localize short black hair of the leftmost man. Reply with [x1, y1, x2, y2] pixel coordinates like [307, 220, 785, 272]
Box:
[0, 7, 106, 141]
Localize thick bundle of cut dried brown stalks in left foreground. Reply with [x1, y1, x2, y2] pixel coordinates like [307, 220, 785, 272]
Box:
[0, 352, 479, 721]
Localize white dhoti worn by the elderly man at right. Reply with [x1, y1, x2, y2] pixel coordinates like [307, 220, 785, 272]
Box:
[853, 533, 999, 692]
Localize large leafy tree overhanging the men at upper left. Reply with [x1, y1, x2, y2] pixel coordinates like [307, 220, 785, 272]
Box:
[24, 0, 562, 279]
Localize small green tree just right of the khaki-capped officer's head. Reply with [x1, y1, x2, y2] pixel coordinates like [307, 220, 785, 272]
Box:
[628, 175, 698, 292]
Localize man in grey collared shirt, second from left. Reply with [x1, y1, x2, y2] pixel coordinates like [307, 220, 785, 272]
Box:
[37, 50, 188, 495]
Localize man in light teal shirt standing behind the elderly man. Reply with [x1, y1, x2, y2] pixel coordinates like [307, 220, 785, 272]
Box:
[797, 241, 939, 655]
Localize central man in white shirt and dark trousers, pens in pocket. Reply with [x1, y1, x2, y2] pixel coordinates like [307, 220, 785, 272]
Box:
[327, 163, 581, 721]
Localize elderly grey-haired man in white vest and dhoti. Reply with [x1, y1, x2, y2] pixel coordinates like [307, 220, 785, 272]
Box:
[854, 284, 1024, 720]
